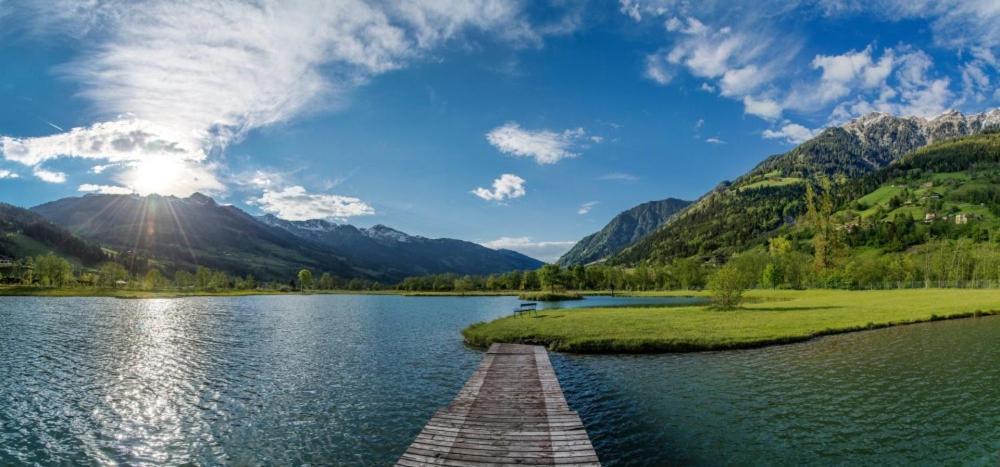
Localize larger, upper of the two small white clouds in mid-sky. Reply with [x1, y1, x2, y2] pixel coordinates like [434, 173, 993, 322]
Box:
[486, 122, 593, 164]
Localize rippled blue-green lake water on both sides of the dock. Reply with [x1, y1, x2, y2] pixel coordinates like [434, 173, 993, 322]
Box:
[0, 295, 1000, 466]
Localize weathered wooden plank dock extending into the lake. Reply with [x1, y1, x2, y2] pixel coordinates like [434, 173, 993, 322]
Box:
[396, 344, 601, 467]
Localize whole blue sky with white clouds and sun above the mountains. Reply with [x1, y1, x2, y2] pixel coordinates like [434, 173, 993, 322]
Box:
[0, 0, 1000, 260]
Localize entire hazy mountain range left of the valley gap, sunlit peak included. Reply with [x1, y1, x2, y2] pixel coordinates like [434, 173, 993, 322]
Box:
[28, 193, 542, 282]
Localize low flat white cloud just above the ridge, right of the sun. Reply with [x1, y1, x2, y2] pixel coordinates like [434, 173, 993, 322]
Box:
[248, 185, 375, 221]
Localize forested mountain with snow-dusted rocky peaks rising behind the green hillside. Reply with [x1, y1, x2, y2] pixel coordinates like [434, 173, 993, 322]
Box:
[610, 109, 1000, 264]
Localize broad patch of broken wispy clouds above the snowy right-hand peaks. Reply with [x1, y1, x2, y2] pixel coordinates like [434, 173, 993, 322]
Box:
[620, 0, 988, 136]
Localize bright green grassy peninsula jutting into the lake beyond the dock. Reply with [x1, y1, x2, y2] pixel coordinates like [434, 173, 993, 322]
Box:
[462, 289, 1000, 353]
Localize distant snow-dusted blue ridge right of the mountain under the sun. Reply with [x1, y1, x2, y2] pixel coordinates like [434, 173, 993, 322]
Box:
[258, 215, 543, 278]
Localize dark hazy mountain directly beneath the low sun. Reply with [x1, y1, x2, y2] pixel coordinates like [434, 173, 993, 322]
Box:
[32, 193, 369, 280]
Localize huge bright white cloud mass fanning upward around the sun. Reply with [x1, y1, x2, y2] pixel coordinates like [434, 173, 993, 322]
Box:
[0, 0, 574, 191]
